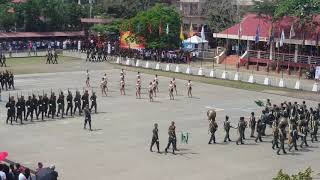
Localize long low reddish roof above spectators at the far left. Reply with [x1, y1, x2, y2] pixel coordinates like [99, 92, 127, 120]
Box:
[0, 31, 85, 39]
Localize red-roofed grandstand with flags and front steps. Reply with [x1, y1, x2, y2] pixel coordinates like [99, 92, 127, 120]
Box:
[213, 14, 320, 69]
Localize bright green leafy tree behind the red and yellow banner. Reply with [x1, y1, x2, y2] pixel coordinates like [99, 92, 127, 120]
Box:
[122, 4, 180, 49]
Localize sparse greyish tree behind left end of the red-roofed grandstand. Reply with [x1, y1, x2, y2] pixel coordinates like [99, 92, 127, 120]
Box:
[203, 0, 239, 32]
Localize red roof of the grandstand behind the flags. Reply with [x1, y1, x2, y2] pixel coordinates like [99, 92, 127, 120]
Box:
[220, 14, 320, 40]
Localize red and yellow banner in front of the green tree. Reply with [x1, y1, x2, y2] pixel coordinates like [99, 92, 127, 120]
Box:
[120, 31, 145, 49]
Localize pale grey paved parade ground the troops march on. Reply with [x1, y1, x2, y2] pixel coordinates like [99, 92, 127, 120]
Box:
[0, 59, 320, 180]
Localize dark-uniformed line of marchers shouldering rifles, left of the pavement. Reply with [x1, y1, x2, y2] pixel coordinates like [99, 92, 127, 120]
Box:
[6, 90, 97, 129]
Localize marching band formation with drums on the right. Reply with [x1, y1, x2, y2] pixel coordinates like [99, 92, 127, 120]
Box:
[207, 99, 320, 155]
